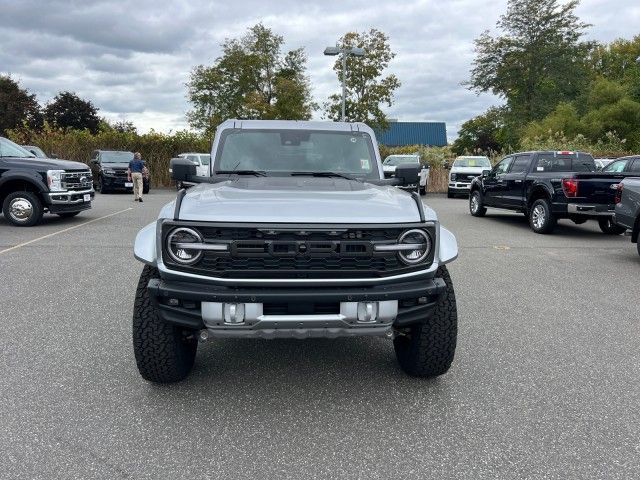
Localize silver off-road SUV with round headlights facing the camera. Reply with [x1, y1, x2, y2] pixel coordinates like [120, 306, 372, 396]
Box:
[133, 120, 458, 382]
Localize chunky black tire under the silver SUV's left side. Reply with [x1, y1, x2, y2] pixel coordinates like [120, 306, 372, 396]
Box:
[133, 265, 198, 383]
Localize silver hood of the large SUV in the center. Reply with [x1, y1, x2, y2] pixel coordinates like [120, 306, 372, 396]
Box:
[170, 177, 435, 224]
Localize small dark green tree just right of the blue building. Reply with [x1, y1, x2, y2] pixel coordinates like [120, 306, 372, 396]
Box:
[453, 107, 509, 155]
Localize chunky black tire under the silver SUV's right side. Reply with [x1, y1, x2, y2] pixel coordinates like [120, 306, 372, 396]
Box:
[393, 266, 458, 377]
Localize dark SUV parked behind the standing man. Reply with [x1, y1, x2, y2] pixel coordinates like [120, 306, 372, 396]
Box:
[89, 150, 150, 193]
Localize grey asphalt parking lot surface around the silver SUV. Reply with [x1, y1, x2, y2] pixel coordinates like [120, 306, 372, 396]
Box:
[0, 190, 640, 479]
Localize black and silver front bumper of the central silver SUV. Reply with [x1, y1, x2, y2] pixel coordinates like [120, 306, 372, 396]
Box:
[148, 278, 446, 338]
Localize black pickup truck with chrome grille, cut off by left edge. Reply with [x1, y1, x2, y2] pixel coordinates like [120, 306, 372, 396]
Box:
[0, 137, 95, 227]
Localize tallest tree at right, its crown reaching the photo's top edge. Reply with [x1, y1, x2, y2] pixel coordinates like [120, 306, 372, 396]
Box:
[467, 0, 594, 124]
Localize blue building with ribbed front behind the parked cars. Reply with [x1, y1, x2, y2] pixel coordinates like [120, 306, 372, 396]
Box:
[376, 121, 447, 147]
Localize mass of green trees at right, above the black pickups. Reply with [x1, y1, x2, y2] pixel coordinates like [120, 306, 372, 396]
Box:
[453, 0, 640, 153]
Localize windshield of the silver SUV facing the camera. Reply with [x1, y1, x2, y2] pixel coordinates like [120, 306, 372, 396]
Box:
[214, 129, 380, 179]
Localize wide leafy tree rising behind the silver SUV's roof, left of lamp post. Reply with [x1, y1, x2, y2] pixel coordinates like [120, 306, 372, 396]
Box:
[187, 24, 315, 133]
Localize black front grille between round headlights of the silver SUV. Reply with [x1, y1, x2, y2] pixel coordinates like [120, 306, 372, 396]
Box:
[162, 222, 435, 279]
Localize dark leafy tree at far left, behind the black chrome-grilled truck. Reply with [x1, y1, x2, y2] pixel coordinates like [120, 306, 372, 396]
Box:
[0, 75, 42, 135]
